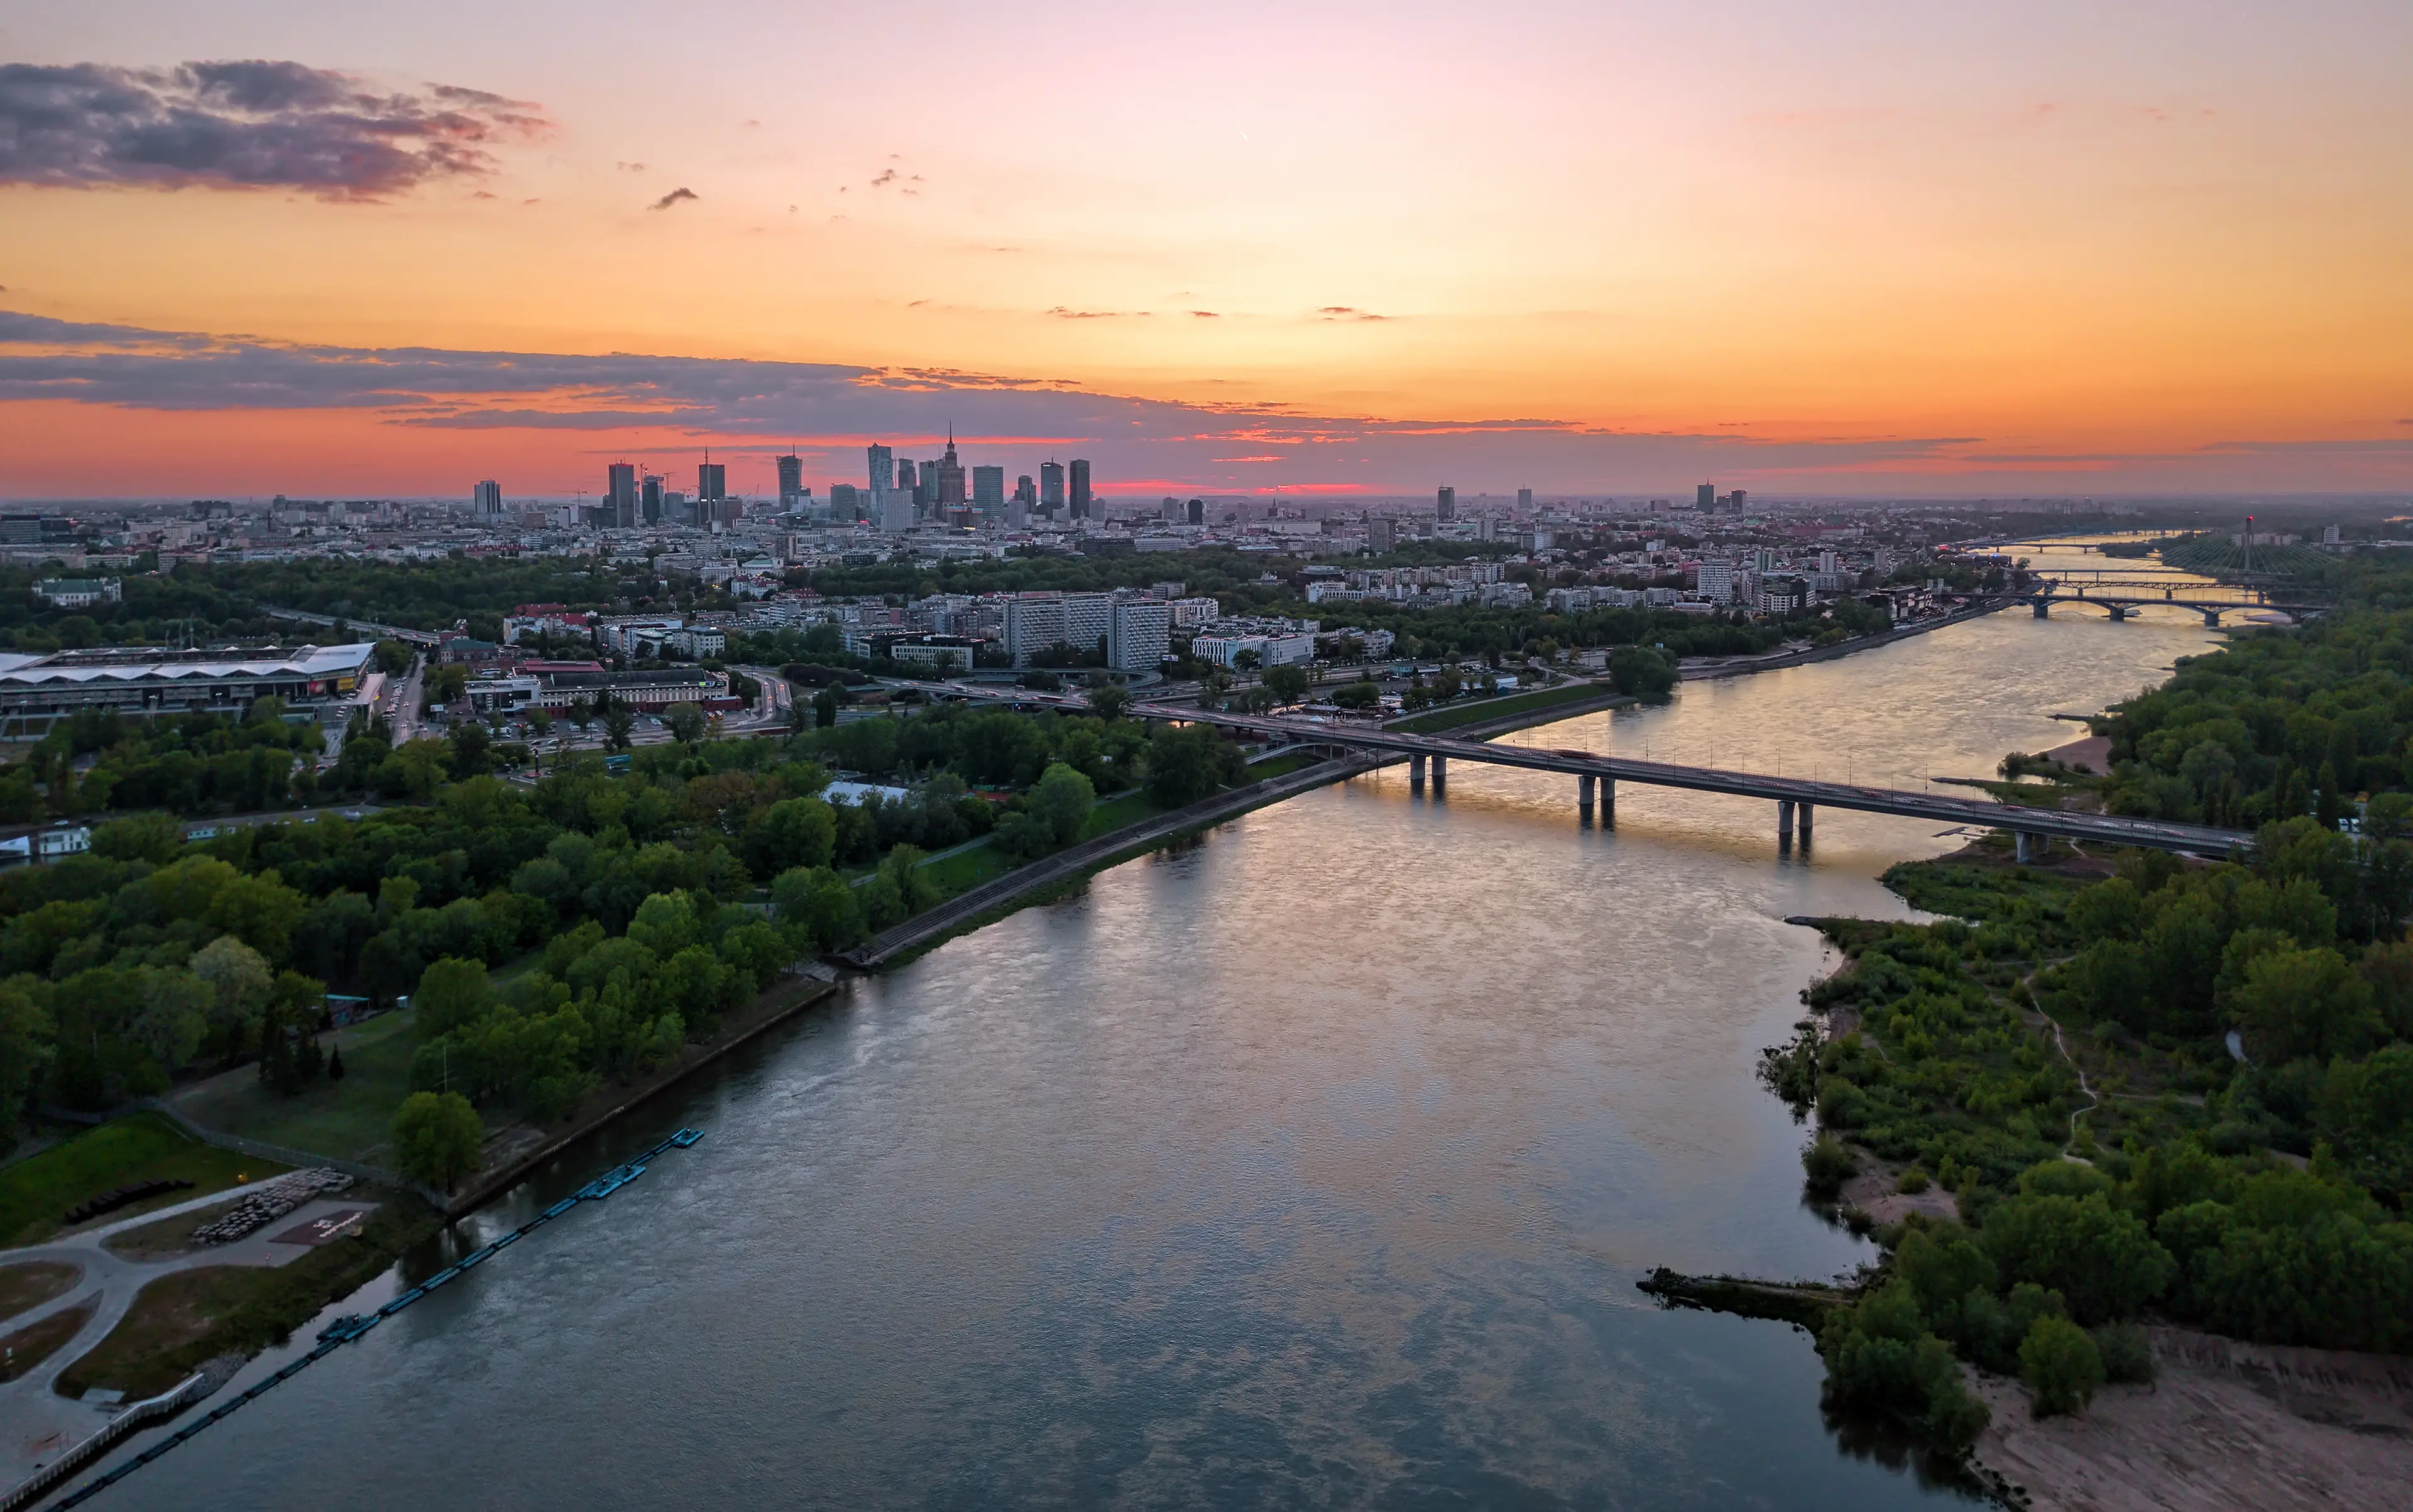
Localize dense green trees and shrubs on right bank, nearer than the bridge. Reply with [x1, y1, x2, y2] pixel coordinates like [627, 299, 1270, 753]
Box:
[1764, 818, 2413, 1442]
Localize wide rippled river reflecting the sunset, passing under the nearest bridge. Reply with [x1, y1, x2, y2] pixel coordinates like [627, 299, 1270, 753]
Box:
[92, 610, 2210, 1512]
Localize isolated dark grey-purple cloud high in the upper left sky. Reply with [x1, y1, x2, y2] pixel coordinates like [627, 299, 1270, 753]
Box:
[0, 60, 545, 200]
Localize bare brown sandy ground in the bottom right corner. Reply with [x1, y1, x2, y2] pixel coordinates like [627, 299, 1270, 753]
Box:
[1971, 1328, 2413, 1512]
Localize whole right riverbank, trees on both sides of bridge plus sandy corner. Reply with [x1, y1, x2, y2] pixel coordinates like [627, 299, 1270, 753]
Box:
[1648, 598, 2413, 1512]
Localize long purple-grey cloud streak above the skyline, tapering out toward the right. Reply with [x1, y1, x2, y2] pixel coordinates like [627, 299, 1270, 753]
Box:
[0, 314, 2007, 490]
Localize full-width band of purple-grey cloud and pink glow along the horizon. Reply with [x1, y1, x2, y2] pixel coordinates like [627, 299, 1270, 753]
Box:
[0, 311, 2413, 496]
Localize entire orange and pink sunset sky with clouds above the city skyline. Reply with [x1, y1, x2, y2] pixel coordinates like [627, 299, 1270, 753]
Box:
[0, 0, 2413, 499]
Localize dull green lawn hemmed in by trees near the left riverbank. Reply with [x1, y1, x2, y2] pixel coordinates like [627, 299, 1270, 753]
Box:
[173, 1011, 420, 1163]
